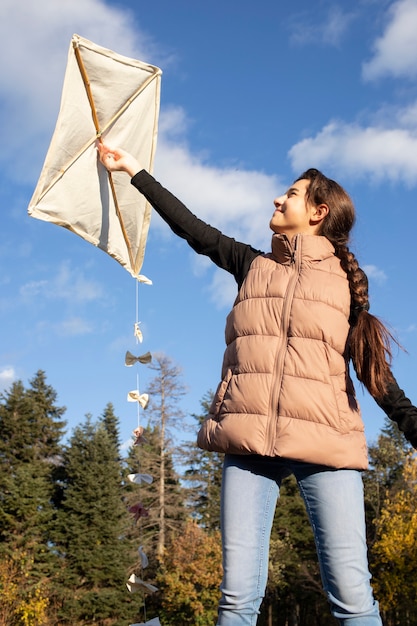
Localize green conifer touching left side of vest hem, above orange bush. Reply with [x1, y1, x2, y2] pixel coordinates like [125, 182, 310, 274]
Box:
[183, 391, 224, 530]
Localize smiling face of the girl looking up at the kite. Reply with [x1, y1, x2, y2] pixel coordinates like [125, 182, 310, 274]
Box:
[269, 180, 325, 239]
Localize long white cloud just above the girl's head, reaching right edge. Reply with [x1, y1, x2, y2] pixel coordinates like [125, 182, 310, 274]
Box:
[289, 104, 417, 186]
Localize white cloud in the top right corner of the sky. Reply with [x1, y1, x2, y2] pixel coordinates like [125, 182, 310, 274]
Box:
[362, 0, 417, 80]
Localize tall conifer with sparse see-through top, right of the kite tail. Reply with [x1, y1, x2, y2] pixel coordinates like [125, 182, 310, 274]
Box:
[125, 354, 185, 613]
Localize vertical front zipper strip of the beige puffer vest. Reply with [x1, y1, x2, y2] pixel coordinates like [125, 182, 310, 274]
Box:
[265, 235, 302, 456]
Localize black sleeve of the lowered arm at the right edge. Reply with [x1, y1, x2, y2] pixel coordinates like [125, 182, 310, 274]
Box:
[377, 378, 417, 449]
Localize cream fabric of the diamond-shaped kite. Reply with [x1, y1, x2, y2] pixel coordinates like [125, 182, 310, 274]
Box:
[28, 35, 162, 280]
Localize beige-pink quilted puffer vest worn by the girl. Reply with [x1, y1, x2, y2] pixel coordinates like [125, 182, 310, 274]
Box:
[198, 235, 368, 469]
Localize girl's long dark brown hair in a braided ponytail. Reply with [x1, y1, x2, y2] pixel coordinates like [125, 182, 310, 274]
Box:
[297, 169, 397, 399]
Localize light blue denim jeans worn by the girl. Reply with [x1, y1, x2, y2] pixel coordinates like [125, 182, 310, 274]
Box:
[217, 455, 382, 626]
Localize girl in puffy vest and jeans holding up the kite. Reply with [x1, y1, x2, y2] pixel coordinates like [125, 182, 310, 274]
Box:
[99, 145, 417, 626]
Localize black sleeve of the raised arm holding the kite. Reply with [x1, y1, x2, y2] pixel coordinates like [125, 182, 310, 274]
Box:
[132, 170, 262, 287]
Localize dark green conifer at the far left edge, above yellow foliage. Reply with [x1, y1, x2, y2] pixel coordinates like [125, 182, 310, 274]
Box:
[0, 371, 65, 586]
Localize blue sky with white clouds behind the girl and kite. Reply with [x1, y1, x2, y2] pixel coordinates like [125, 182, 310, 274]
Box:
[0, 0, 417, 445]
